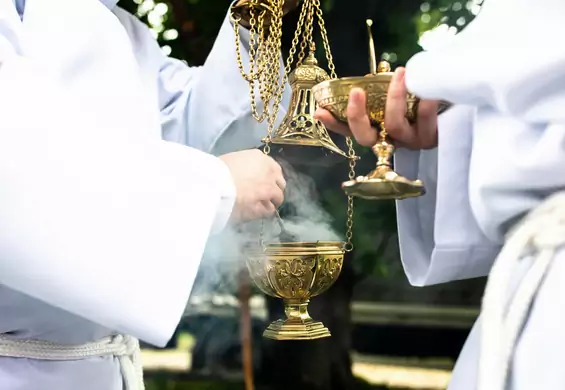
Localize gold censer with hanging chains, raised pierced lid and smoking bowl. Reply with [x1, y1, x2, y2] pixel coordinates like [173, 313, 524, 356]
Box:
[228, 0, 357, 340]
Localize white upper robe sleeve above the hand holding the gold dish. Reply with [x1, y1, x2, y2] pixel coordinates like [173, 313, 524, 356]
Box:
[406, 0, 565, 123]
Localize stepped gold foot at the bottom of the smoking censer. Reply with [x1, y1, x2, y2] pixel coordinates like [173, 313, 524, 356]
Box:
[263, 319, 331, 341]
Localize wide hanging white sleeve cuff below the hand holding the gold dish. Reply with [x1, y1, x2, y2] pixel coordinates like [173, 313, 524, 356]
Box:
[395, 106, 499, 286]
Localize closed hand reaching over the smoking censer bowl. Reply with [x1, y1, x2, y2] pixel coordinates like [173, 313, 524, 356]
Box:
[220, 149, 286, 223]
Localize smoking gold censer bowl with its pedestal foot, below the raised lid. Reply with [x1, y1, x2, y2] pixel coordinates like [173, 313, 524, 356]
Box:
[246, 241, 345, 340]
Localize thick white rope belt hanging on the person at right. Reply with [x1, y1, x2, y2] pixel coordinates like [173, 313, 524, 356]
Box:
[478, 193, 565, 390]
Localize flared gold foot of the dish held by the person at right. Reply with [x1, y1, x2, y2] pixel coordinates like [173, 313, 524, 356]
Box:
[341, 166, 426, 200]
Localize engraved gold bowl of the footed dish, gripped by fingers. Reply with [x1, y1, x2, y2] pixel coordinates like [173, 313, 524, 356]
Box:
[312, 72, 451, 126]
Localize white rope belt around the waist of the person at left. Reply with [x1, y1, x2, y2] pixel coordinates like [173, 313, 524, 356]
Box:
[0, 335, 145, 390]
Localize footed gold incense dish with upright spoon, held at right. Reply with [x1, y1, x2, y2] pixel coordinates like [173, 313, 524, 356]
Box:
[312, 20, 449, 200]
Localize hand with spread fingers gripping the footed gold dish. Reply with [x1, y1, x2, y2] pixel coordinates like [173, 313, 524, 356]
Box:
[315, 68, 439, 149]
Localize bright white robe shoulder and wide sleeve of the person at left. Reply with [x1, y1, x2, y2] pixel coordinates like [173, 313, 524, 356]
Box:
[0, 0, 230, 346]
